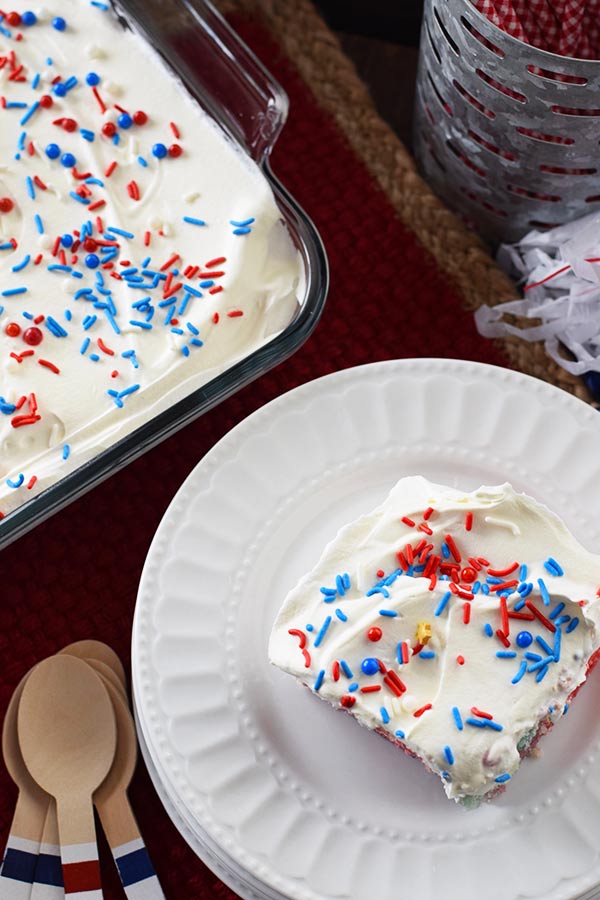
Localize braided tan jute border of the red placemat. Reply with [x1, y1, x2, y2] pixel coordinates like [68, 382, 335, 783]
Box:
[218, 0, 591, 402]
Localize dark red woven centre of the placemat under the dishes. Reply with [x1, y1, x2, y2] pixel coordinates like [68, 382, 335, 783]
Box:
[0, 7, 505, 900]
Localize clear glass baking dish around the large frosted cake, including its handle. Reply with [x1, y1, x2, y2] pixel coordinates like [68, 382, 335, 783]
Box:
[0, 0, 329, 549]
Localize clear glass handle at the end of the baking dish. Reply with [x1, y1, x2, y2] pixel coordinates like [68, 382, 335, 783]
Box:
[114, 0, 289, 163]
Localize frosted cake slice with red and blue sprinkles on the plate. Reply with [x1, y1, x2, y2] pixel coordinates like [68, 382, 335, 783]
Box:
[269, 477, 600, 806]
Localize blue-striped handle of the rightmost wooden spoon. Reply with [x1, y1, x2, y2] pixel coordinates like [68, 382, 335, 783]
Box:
[96, 791, 165, 900]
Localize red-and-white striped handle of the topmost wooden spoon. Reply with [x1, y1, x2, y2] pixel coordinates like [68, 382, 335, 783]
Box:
[56, 796, 103, 900]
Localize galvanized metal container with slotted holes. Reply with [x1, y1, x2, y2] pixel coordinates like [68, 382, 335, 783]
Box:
[414, 0, 600, 244]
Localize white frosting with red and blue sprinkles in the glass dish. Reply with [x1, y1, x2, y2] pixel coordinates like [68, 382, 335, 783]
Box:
[0, 0, 301, 513]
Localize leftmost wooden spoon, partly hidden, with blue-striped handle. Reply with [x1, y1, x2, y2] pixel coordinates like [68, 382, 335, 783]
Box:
[0, 673, 50, 900]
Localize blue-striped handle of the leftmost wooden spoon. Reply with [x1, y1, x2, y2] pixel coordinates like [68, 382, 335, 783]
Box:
[0, 791, 47, 900]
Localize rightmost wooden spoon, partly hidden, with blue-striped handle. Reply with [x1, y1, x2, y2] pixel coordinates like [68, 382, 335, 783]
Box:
[94, 682, 164, 900]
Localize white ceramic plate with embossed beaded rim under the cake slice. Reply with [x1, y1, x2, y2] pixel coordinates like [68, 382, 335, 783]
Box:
[133, 359, 600, 900]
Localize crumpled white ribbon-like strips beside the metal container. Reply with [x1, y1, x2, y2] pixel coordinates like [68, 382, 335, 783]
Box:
[475, 213, 600, 375]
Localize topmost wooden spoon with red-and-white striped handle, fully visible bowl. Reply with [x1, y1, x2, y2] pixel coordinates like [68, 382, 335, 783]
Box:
[18, 655, 117, 900]
